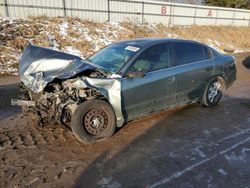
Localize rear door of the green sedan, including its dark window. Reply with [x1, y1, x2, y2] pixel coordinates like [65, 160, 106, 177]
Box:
[173, 42, 214, 103]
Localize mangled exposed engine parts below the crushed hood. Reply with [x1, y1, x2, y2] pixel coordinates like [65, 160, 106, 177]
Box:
[20, 72, 104, 126]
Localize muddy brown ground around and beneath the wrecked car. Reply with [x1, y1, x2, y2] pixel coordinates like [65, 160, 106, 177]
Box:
[0, 53, 250, 188]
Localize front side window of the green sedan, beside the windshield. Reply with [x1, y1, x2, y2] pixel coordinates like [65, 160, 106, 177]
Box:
[129, 43, 171, 73]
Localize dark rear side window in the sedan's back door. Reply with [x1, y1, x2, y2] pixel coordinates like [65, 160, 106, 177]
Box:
[174, 42, 207, 66]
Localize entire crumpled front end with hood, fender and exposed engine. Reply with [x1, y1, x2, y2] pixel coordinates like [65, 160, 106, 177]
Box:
[12, 46, 124, 127]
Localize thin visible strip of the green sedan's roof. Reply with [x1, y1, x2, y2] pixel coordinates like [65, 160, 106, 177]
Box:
[115, 38, 202, 48]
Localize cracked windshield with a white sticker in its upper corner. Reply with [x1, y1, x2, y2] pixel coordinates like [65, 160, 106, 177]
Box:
[87, 44, 139, 73]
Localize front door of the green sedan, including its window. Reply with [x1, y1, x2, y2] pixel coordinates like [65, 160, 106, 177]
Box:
[121, 43, 176, 120]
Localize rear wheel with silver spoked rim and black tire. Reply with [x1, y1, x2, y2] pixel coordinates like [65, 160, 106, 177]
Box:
[201, 78, 223, 107]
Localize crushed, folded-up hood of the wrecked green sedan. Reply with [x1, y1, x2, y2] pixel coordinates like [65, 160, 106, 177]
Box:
[19, 45, 101, 93]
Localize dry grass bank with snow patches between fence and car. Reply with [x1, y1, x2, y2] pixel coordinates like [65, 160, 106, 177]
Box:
[0, 16, 250, 75]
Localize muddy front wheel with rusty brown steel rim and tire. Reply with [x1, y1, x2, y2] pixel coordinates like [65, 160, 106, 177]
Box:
[71, 99, 116, 143]
